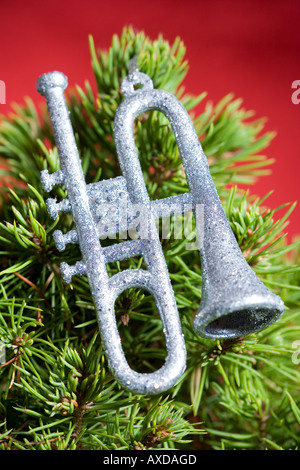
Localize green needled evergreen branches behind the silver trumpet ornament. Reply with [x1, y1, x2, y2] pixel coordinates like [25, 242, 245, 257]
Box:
[0, 28, 300, 450]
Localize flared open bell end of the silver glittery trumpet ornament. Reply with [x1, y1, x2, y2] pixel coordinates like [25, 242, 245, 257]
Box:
[194, 223, 284, 340]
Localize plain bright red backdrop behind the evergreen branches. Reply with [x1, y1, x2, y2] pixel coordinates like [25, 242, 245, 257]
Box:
[0, 0, 300, 241]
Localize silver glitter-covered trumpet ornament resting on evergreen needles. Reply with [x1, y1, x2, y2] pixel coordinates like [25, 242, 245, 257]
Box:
[37, 69, 284, 395]
